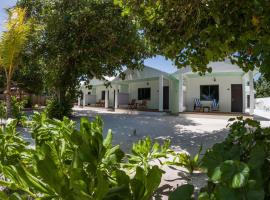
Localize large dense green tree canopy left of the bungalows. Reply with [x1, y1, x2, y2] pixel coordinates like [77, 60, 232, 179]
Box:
[18, 0, 149, 115]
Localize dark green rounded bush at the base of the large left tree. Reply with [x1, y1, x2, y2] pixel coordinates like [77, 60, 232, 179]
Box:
[46, 98, 73, 119]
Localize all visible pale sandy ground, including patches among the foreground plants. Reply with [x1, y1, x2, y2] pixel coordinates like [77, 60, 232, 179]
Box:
[18, 107, 270, 200]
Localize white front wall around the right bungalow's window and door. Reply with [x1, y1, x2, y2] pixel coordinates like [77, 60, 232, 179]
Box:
[185, 75, 242, 112]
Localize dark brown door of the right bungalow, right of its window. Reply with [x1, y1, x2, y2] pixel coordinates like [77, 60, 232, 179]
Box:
[231, 84, 243, 112]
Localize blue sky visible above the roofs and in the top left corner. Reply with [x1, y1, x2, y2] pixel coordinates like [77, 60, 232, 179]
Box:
[0, 0, 176, 73]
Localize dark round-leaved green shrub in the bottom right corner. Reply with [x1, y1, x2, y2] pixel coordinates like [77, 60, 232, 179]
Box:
[170, 118, 270, 200]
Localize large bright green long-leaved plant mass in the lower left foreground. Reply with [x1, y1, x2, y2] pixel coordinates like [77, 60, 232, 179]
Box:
[0, 113, 165, 200]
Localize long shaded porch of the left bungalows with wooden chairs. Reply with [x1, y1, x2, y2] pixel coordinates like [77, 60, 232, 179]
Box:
[77, 75, 173, 112]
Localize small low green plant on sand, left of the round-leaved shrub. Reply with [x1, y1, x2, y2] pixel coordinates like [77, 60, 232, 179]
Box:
[168, 146, 202, 174]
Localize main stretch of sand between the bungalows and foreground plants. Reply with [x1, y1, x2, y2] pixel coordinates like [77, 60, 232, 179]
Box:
[73, 110, 228, 155]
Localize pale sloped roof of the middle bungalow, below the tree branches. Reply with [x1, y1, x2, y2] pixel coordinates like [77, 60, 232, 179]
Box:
[112, 66, 169, 82]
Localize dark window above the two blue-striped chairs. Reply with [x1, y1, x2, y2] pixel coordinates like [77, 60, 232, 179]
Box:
[200, 85, 219, 101]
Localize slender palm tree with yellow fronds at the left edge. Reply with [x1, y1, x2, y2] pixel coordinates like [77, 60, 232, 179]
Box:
[0, 7, 30, 117]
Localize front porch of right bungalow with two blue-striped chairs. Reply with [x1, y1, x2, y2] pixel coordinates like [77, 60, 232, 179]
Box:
[176, 70, 255, 115]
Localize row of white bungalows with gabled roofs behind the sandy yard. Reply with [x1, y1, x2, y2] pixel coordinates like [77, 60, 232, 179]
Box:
[78, 62, 254, 114]
